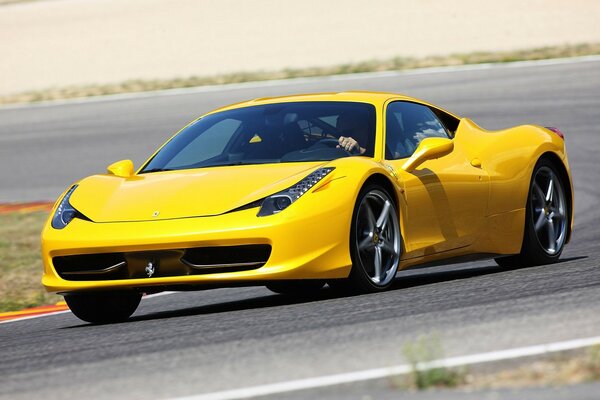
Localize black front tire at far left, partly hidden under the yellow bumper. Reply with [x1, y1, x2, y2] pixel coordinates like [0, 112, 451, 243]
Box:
[65, 292, 142, 324]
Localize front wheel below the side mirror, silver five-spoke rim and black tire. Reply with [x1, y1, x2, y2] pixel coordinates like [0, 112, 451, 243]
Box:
[328, 184, 402, 293]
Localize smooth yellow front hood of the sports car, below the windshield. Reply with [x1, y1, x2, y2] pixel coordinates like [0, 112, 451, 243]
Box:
[70, 162, 324, 222]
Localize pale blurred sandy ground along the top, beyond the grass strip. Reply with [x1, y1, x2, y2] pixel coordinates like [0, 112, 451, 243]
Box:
[0, 0, 600, 96]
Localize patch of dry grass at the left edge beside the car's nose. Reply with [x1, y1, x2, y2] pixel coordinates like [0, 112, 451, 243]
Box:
[0, 212, 61, 312]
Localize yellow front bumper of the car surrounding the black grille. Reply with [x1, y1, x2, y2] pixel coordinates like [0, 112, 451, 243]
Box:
[42, 200, 353, 292]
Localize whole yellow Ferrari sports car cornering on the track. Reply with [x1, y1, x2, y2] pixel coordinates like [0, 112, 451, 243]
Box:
[42, 92, 573, 323]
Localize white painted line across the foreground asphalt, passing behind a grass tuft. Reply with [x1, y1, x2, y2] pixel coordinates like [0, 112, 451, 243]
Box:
[172, 336, 600, 400]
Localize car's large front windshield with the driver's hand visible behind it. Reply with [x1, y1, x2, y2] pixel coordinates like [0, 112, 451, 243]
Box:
[141, 102, 375, 173]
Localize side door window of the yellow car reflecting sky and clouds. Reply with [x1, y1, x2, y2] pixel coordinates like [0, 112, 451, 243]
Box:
[385, 101, 449, 160]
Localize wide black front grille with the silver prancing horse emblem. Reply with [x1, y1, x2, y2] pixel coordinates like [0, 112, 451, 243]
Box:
[52, 245, 271, 281]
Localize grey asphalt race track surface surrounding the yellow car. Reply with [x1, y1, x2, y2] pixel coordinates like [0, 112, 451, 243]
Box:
[0, 59, 600, 399]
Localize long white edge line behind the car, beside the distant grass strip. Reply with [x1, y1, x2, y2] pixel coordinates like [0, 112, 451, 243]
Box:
[0, 55, 600, 111]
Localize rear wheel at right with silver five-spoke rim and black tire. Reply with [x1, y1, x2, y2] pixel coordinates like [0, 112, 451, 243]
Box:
[495, 158, 571, 268]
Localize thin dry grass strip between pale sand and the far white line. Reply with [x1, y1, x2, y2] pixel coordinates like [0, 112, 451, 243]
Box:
[0, 43, 600, 105]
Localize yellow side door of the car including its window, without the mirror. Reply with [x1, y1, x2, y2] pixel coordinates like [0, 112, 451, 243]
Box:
[385, 101, 489, 258]
